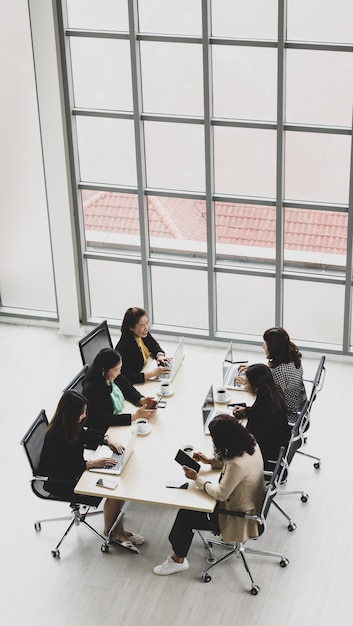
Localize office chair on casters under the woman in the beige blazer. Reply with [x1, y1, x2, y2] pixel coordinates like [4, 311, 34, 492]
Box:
[197, 447, 289, 596]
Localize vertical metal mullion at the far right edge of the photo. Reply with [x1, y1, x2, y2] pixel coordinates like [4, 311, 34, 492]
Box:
[343, 110, 353, 354]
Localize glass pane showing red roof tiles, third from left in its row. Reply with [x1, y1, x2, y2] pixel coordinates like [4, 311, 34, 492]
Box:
[215, 202, 276, 267]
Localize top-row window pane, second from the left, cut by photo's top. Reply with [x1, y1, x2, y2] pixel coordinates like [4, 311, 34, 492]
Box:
[138, 0, 201, 35]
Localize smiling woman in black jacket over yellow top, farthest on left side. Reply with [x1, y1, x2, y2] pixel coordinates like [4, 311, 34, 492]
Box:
[115, 307, 170, 384]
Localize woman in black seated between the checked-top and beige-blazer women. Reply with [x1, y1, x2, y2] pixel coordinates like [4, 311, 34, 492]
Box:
[233, 363, 291, 469]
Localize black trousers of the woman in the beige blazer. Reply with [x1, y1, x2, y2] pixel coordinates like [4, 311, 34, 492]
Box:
[169, 509, 219, 557]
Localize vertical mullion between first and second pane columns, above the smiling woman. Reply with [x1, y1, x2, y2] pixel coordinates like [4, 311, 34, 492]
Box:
[128, 0, 153, 312]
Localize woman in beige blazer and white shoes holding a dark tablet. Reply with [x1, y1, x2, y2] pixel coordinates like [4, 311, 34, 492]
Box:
[153, 414, 265, 576]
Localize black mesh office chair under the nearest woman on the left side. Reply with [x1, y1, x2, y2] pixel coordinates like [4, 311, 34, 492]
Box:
[21, 409, 109, 557]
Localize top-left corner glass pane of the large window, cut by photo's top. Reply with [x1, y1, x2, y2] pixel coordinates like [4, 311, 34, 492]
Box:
[66, 0, 129, 31]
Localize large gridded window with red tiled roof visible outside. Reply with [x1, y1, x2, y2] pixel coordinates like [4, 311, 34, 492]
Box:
[58, 0, 353, 353]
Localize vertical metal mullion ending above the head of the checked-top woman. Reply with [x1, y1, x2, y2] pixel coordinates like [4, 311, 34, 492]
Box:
[275, 0, 287, 326]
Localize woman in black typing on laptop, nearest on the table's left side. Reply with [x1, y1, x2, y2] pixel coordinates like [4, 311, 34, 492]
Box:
[38, 390, 145, 552]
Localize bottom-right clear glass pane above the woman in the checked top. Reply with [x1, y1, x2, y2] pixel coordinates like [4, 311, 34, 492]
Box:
[283, 280, 344, 347]
